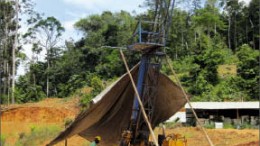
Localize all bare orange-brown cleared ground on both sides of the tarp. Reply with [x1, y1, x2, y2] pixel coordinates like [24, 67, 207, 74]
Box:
[1, 98, 259, 146]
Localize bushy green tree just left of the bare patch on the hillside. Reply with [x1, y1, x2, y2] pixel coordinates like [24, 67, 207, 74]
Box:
[182, 35, 232, 100]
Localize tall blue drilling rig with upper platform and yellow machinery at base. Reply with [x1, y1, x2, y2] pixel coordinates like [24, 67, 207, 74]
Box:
[120, 0, 186, 146]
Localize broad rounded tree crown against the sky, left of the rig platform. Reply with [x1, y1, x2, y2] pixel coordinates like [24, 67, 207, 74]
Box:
[75, 11, 135, 48]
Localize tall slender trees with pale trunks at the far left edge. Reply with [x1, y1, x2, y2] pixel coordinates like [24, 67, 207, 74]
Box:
[0, 1, 18, 103]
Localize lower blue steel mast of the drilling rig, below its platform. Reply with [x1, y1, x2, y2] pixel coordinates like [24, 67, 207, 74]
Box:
[130, 52, 164, 145]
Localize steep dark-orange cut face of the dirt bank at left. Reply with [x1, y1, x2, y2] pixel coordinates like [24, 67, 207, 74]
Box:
[1, 107, 75, 123]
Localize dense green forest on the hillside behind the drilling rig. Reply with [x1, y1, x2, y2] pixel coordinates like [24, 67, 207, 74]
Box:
[0, 0, 260, 106]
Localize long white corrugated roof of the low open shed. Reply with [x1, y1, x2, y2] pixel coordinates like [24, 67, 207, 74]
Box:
[185, 102, 260, 109]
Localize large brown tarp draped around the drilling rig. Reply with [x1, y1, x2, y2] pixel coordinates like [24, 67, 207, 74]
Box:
[49, 66, 186, 146]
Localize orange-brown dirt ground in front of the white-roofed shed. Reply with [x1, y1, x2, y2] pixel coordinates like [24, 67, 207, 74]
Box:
[157, 127, 259, 146]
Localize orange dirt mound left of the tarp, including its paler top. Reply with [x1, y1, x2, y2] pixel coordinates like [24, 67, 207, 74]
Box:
[1, 98, 79, 123]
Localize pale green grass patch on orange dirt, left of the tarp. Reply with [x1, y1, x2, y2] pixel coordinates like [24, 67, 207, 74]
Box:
[15, 125, 61, 146]
